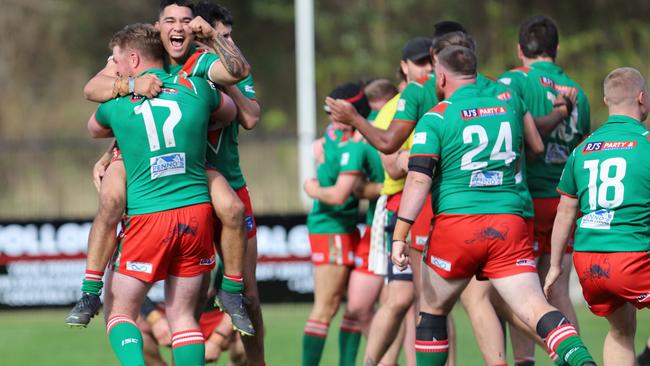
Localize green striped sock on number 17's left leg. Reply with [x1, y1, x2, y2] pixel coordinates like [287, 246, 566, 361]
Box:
[106, 315, 144, 366]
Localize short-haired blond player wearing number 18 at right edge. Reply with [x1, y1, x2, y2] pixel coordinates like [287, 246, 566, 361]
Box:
[544, 67, 650, 365]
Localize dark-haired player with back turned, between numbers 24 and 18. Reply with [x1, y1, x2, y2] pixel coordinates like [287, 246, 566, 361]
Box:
[499, 16, 591, 344]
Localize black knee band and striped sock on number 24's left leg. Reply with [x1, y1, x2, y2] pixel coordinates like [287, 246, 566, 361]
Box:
[415, 312, 449, 366]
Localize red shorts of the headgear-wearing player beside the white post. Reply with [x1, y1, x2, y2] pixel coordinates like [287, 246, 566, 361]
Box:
[309, 229, 359, 267]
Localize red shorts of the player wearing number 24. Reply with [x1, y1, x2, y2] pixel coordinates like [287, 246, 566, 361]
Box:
[425, 214, 537, 279]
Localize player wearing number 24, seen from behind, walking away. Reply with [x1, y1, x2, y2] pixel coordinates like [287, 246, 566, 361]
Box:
[392, 46, 594, 365]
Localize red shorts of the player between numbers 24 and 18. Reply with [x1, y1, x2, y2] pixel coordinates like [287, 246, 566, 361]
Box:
[533, 197, 575, 257]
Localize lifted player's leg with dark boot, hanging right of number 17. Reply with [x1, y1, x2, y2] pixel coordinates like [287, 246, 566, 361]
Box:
[206, 169, 255, 336]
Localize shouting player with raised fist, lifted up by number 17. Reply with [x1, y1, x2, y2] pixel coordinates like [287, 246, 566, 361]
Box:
[66, 0, 254, 334]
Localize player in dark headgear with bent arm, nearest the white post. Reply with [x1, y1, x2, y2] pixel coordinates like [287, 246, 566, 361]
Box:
[302, 83, 383, 365]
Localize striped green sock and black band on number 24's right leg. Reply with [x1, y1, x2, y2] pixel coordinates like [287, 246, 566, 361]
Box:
[537, 310, 594, 366]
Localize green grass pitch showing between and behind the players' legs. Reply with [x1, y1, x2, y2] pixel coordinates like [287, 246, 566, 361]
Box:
[0, 304, 650, 366]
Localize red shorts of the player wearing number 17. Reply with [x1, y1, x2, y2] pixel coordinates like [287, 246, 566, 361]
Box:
[113, 203, 215, 282]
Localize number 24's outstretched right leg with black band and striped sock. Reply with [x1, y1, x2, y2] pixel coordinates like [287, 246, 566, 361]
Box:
[490, 272, 595, 365]
